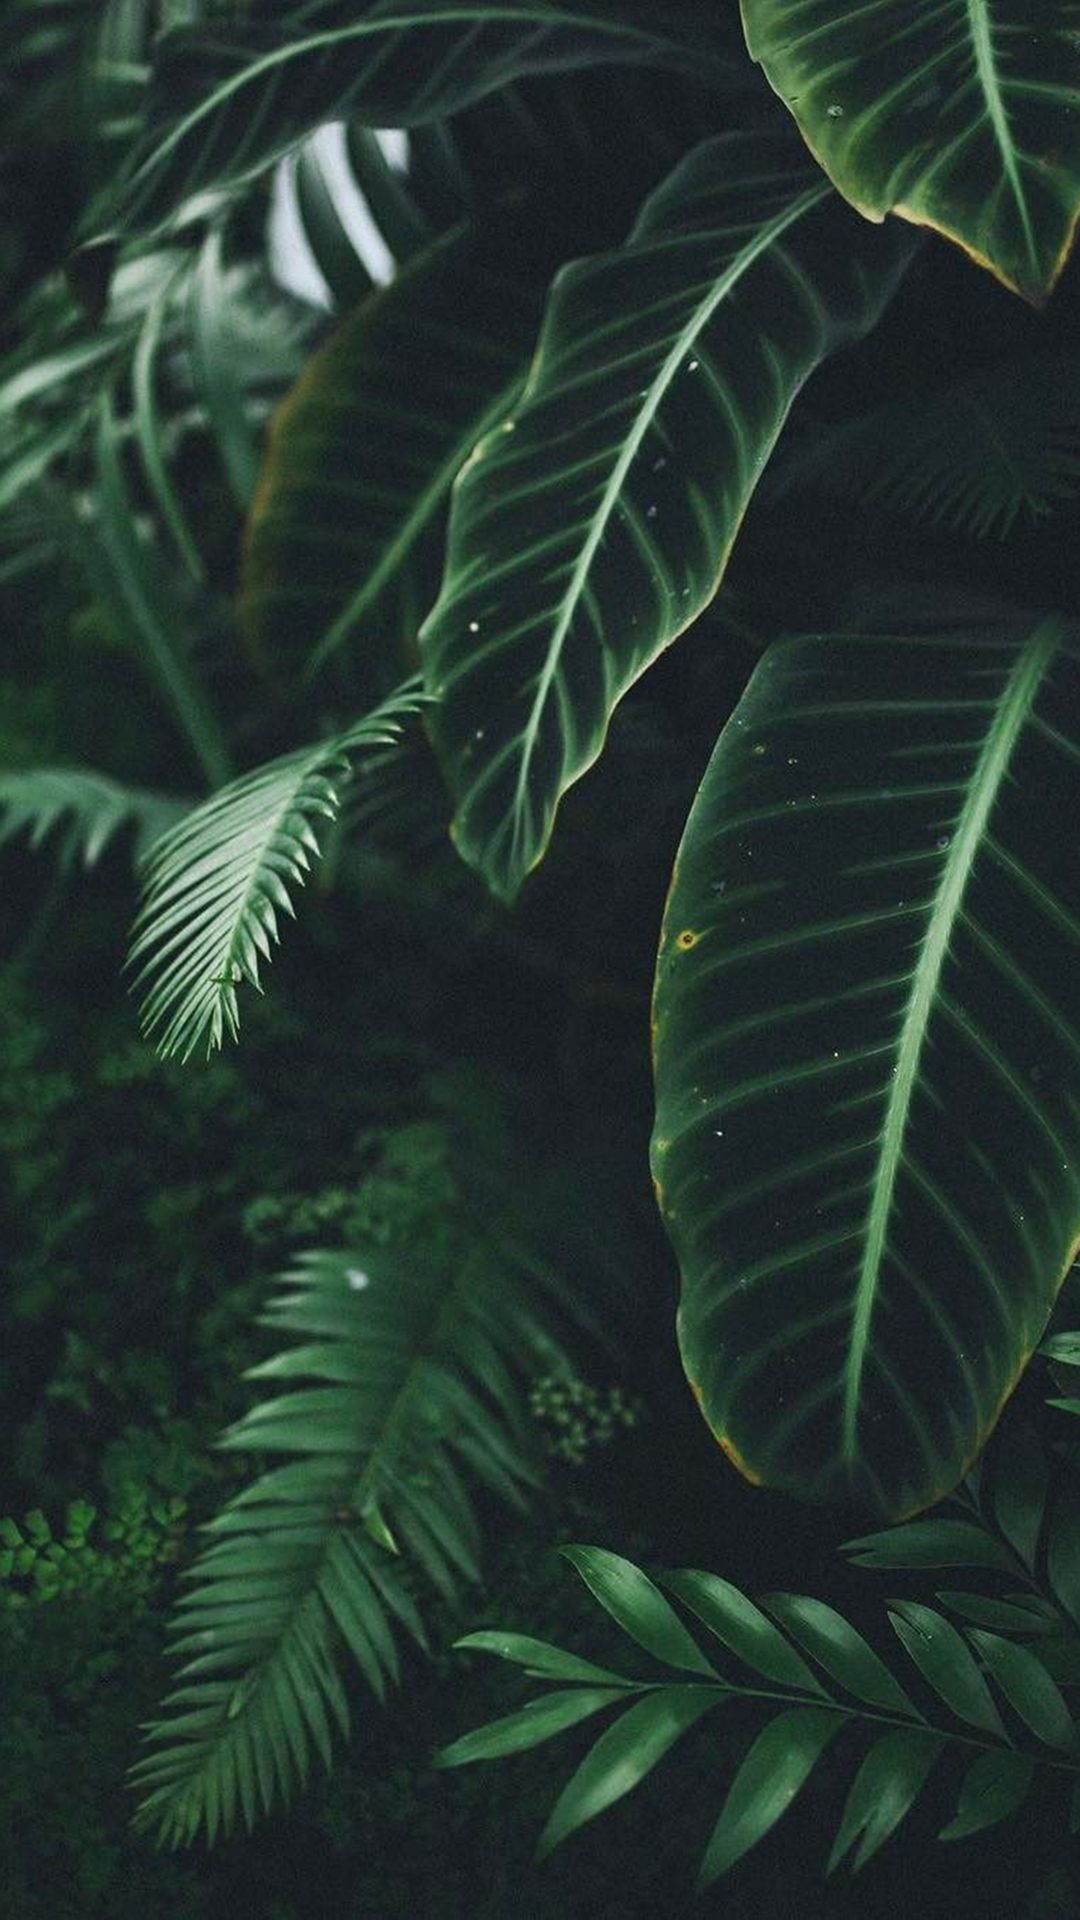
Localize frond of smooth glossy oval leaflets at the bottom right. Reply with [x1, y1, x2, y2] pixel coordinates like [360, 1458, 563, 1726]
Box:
[440, 1546, 1080, 1885]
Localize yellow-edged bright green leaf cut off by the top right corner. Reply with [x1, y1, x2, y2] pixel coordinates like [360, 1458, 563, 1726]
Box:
[742, 0, 1080, 300]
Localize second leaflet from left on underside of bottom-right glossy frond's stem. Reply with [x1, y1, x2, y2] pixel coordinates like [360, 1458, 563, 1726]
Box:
[536, 1686, 724, 1859]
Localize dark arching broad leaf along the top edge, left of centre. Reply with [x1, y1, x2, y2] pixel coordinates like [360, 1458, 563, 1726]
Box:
[110, 0, 730, 225]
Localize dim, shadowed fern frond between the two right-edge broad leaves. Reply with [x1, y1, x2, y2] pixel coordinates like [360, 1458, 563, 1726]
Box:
[773, 355, 1080, 540]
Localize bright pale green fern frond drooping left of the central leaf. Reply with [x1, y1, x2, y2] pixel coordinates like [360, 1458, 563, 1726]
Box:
[129, 682, 423, 1060]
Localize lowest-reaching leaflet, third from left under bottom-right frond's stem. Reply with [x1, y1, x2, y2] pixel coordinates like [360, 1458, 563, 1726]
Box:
[700, 1707, 844, 1887]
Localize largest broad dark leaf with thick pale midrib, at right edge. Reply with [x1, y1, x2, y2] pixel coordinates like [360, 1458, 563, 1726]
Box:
[653, 620, 1080, 1517]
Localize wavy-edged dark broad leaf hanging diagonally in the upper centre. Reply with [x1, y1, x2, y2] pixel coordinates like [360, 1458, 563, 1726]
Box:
[421, 134, 905, 897]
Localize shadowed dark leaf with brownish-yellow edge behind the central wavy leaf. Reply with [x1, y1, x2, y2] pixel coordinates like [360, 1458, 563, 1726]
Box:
[238, 238, 540, 687]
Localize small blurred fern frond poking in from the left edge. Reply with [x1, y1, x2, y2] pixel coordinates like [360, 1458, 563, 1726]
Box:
[0, 766, 186, 868]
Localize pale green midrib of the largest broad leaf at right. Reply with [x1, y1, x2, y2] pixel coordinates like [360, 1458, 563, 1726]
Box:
[844, 620, 1061, 1467]
